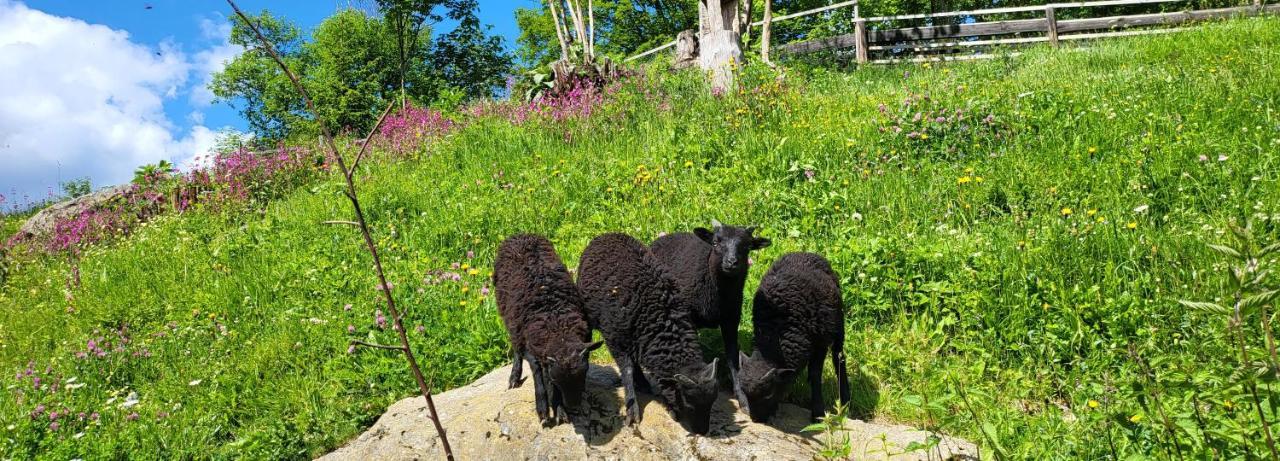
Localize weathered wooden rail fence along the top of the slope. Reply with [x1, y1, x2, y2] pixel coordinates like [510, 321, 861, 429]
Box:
[627, 0, 1280, 64]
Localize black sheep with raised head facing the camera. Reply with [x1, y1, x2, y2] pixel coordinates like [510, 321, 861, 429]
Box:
[650, 220, 772, 374]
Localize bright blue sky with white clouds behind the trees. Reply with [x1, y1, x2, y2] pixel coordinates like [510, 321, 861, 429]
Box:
[0, 0, 539, 209]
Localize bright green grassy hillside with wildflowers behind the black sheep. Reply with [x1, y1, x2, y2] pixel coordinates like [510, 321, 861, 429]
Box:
[0, 19, 1280, 458]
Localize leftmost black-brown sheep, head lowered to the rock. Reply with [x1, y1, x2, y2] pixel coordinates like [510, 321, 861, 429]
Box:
[493, 234, 600, 426]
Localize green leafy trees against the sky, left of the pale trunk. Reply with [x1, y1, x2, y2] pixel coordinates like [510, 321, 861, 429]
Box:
[210, 0, 509, 141]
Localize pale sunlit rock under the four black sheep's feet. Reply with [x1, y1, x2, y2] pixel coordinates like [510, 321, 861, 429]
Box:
[321, 365, 978, 461]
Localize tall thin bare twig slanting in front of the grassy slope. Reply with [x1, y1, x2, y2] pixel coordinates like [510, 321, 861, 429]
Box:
[227, 0, 453, 461]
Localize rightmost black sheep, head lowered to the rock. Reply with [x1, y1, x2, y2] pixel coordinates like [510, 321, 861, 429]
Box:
[735, 252, 849, 423]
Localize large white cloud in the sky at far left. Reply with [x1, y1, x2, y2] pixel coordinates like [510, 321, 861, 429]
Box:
[0, 0, 227, 198]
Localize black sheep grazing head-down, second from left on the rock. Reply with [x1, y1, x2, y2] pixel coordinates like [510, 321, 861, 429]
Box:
[577, 233, 718, 434]
